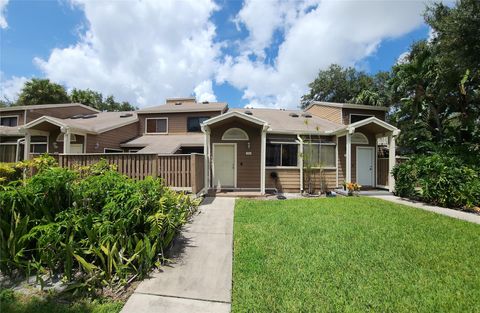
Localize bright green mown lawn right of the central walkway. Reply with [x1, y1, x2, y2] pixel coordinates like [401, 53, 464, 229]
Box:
[233, 197, 480, 313]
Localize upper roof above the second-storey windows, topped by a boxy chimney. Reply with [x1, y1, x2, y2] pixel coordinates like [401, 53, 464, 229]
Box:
[137, 99, 227, 114]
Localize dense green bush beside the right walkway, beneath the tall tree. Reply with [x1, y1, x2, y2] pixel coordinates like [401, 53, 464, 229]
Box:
[393, 154, 480, 208]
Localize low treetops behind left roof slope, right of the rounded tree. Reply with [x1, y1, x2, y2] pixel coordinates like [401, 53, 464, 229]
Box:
[70, 89, 136, 111]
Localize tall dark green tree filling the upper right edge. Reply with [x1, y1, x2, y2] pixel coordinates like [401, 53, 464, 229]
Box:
[391, 0, 480, 160]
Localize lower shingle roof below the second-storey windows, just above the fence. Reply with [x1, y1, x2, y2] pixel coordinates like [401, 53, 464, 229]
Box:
[120, 133, 204, 154]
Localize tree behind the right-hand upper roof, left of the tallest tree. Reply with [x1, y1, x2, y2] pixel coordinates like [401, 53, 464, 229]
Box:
[302, 64, 390, 107]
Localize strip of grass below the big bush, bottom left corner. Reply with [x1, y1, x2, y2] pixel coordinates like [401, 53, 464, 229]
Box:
[0, 289, 123, 313]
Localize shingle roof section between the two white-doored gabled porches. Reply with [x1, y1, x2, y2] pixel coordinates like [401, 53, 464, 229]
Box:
[231, 109, 343, 133]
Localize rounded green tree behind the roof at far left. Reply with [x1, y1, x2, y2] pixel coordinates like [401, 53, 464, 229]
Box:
[16, 78, 70, 105]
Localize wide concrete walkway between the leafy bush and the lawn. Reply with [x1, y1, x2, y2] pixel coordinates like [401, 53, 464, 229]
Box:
[121, 198, 235, 313]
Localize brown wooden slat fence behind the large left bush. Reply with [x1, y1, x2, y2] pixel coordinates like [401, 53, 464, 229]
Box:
[54, 153, 204, 193]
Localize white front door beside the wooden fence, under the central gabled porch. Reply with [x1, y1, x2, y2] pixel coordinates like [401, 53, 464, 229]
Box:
[213, 143, 237, 188]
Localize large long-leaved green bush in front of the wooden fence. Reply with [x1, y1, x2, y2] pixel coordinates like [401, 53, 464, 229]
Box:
[0, 158, 197, 290]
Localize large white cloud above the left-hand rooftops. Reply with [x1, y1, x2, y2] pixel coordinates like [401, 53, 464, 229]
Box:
[35, 0, 220, 106]
